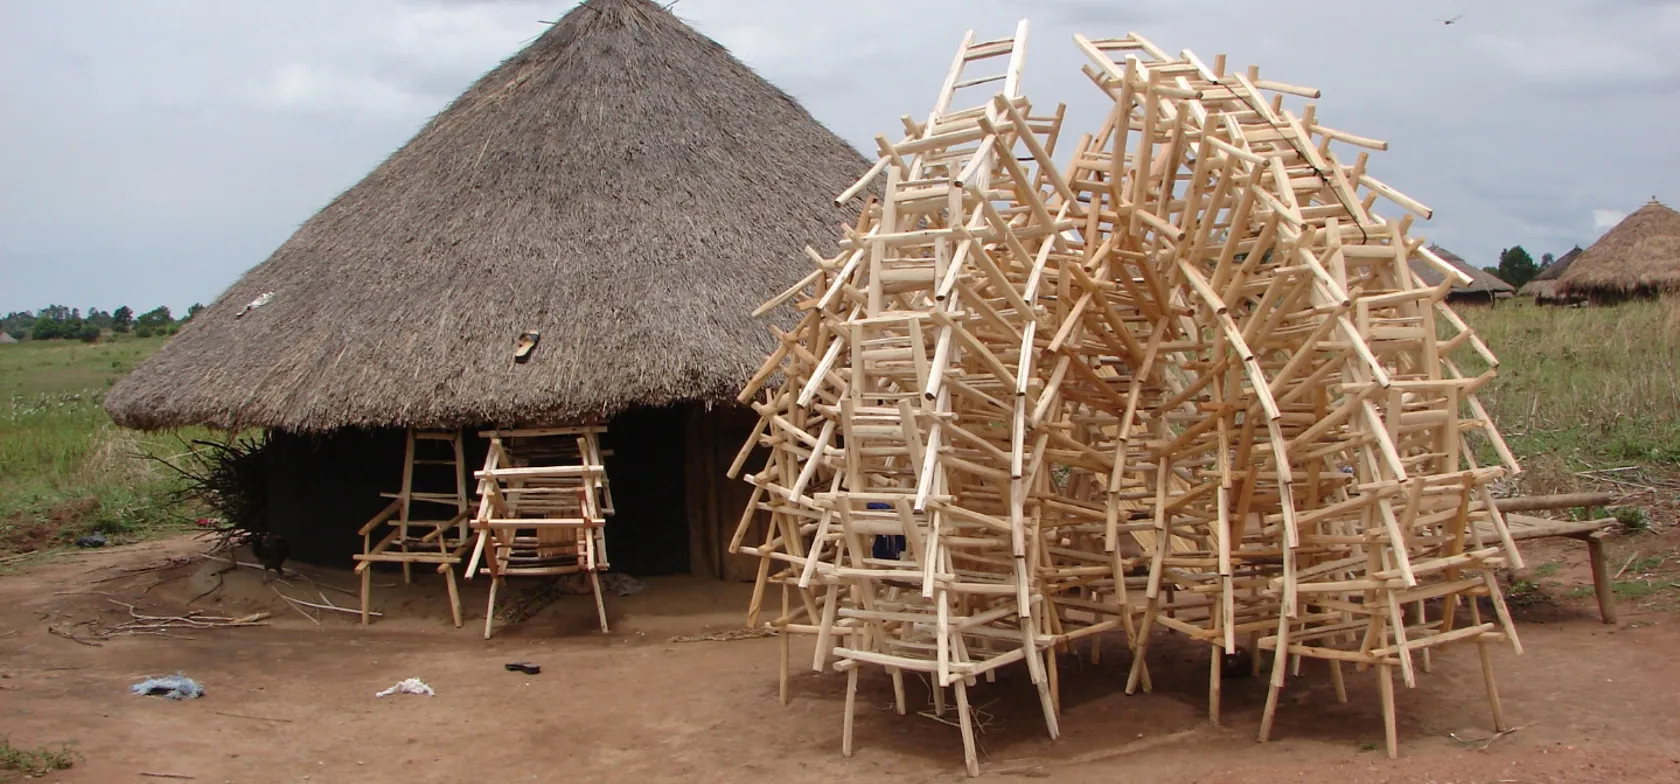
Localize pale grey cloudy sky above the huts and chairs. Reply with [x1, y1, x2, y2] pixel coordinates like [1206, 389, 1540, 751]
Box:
[0, 0, 1680, 312]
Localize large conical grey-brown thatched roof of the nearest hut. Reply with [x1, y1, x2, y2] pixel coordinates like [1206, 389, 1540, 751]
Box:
[106, 0, 869, 431]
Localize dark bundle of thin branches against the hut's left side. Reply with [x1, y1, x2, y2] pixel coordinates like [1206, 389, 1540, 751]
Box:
[156, 433, 269, 549]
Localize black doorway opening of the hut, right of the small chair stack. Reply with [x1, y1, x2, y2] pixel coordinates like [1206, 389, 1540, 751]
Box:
[601, 406, 689, 576]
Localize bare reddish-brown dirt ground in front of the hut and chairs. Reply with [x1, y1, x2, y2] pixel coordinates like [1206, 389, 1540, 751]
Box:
[0, 531, 1680, 784]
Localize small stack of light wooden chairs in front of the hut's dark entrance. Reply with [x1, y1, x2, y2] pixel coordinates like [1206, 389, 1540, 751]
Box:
[467, 426, 613, 640]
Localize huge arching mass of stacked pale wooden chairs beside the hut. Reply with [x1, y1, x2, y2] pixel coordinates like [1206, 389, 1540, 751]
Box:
[731, 22, 1520, 774]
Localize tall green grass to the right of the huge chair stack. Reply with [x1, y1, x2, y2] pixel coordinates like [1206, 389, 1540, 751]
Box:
[1458, 299, 1680, 492]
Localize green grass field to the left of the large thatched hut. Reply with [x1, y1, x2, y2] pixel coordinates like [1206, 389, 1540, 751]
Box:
[0, 336, 204, 554]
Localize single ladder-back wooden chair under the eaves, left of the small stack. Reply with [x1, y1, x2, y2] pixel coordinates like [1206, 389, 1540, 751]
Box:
[356, 430, 472, 626]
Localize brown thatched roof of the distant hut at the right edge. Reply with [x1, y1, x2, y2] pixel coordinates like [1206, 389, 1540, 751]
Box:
[1557, 198, 1680, 297]
